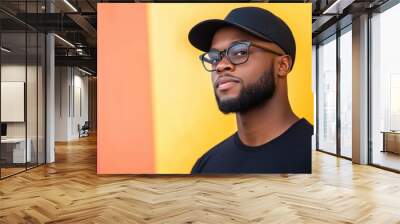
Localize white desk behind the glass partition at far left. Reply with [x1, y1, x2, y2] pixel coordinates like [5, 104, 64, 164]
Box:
[1, 138, 32, 163]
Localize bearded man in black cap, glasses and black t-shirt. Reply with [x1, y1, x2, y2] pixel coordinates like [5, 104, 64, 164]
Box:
[189, 7, 313, 174]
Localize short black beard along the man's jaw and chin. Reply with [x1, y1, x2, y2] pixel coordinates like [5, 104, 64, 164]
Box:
[214, 66, 276, 114]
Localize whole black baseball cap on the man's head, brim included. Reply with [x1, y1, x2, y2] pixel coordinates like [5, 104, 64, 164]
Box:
[188, 7, 296, 67]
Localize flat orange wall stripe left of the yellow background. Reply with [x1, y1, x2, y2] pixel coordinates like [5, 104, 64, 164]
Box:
[97, 3, 155, 174]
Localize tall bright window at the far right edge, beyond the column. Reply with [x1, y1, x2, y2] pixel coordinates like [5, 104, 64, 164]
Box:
[370, 1, 400, 170]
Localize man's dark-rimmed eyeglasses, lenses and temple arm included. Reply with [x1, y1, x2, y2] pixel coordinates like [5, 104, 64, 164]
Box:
[199, 41, 284, 72]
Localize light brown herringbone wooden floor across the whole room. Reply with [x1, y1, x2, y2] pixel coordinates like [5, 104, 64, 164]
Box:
[0, 134, 400, 224]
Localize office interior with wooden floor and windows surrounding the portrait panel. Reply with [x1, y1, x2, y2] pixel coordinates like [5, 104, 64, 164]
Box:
[0, 0, 400, 223]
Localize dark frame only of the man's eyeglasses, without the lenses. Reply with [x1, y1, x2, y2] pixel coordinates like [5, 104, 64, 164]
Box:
[199, 40, 286, 72]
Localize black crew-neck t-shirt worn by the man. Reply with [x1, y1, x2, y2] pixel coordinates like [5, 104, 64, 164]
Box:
[191, 118, 313, 174]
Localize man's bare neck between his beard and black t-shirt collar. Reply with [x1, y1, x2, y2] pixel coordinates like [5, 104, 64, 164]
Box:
[236, 95, 299, 146]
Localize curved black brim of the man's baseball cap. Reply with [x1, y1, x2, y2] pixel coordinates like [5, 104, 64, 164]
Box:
[188, 19, 270, 52]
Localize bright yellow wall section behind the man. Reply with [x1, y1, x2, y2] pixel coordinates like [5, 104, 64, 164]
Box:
[148, 3, 313, 173]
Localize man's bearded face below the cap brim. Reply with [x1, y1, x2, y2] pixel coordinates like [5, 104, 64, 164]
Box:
[211, 27, 282, 113]
